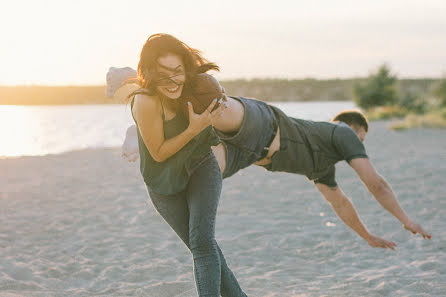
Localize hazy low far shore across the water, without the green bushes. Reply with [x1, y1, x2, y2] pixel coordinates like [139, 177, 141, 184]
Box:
[0, 78, 439, 105]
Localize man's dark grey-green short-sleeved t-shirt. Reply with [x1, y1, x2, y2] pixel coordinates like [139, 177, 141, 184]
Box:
[264, 106, 368, 187]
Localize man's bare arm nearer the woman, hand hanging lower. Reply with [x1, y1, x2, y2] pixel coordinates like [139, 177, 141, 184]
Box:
[315, 183, 396, 250]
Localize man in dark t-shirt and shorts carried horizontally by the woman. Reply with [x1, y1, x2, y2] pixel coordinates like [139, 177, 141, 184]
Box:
[107, 67, 431, 249]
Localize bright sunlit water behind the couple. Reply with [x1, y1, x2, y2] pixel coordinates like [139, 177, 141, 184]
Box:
[0, 101, 355, 157]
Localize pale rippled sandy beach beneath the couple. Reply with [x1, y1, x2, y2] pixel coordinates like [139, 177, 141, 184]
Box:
[0, 122, 446, 297]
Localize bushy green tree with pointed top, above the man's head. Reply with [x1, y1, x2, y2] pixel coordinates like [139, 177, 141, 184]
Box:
[353, 64, 398, 109]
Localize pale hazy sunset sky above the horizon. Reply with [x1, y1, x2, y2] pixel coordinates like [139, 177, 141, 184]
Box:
[0, 0, 446, 85]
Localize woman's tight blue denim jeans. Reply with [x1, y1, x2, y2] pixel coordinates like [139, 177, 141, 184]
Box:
[148, 153, 246, 297]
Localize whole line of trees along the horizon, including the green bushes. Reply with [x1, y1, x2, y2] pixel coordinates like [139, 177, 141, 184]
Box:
[0, 72, 446, 108]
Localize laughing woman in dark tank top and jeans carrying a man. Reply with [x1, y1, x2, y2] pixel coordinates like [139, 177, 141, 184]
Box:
[129, 34, 246, 297]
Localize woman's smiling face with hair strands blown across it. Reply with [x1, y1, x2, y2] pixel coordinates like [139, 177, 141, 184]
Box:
[156, 53, 186, 99]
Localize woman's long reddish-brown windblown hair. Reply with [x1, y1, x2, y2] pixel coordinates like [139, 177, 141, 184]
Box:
[128, 33, 220, 98]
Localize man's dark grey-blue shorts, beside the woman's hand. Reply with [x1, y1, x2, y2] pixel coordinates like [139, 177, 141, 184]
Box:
[216, 97, 277, 178]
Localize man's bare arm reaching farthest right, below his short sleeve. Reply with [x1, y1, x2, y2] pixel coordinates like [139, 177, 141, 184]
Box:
[349, 158, 432, 239]
